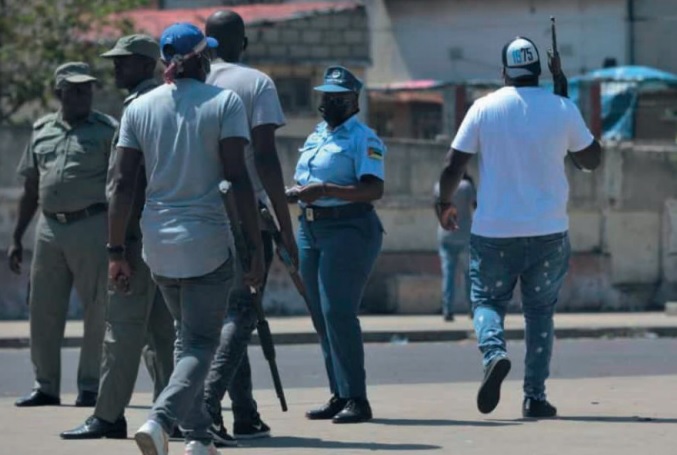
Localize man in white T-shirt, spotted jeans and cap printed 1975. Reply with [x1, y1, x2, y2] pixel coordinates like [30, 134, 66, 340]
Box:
[437, 37, 602, 418]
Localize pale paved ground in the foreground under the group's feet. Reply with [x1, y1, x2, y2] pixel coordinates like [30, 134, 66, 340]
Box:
[0, 376, 677, 455]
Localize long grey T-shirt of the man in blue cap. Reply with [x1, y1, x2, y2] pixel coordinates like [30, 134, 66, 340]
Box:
[118, 79, 249, 278]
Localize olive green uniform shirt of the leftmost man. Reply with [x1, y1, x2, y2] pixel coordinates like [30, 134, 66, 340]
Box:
[18, 111, 118, 212]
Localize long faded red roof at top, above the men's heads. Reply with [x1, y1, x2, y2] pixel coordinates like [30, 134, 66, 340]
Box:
[115, 1, 362, 37]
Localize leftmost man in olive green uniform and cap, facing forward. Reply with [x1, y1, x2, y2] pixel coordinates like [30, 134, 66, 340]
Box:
[8, 62, 117, 406]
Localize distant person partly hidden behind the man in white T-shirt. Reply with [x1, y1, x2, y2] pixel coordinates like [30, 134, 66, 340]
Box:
[434, 173, 477, 322]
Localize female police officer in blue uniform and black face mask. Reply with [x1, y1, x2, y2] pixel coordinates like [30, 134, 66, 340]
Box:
[287, 66, 386, 423]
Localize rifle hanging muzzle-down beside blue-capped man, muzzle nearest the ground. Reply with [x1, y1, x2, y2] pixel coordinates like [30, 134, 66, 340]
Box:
[219, 180, 287, 412]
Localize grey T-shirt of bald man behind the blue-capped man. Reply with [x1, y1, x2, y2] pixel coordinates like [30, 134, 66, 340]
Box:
[207, 59, 285, 200]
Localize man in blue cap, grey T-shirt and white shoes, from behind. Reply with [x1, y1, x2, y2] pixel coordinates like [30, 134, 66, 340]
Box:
[108, 23, 263, 455]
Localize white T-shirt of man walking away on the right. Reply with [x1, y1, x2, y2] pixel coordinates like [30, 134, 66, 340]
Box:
[451, 87, 594, 237]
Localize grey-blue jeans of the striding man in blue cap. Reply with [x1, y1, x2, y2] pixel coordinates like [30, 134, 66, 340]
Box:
[150, 256, 233, 443]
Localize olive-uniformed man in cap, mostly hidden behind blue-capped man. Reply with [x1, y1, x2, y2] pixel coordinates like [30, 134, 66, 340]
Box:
[61, 35, 174, 439]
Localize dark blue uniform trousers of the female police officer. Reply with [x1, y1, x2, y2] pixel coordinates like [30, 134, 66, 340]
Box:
[297, 211, 383, 398]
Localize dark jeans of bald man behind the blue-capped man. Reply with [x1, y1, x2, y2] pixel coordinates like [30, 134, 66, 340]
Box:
[205, 232, 273, 422]
